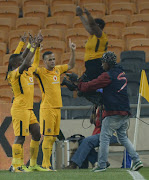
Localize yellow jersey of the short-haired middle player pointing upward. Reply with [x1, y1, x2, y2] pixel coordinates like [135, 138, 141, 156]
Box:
[36, 64, 68, 108]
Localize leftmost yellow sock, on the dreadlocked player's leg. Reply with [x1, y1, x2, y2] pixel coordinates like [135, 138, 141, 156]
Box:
[12, 144, 23, 168]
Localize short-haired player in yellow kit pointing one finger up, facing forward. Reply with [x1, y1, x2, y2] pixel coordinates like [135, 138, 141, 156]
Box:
[35, 41, 76, 171]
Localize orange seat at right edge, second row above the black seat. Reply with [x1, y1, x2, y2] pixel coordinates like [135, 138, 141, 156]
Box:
[122, 26, 148, 50]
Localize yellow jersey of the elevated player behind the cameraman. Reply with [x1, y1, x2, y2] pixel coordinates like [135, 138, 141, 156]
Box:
[84, 32, 108, 61]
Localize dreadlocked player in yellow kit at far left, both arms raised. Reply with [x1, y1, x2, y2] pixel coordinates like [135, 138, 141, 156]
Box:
[6, 33, 45, 172]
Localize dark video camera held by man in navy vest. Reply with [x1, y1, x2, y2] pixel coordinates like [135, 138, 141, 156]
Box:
[61, 73, 103, 106]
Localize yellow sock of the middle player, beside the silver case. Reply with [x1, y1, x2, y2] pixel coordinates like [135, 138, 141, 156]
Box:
[42, 136, 56, 168]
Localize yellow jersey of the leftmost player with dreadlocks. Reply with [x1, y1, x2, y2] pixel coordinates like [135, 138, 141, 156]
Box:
[8, 67, 34, 109]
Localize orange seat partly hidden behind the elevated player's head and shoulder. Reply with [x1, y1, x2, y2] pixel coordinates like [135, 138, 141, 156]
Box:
[104, 26, 121, 39]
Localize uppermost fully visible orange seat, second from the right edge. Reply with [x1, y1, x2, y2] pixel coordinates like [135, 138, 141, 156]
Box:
[110, 2, 136, 16]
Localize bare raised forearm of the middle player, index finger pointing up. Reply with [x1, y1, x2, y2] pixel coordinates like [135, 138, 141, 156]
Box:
[68, 39, 76, 70]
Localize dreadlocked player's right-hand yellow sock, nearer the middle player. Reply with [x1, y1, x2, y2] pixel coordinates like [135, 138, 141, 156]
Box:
[30, 140, 39, 166]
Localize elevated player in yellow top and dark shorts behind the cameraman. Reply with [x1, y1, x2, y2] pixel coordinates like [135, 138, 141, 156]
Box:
[76, 6, 108, 80]
